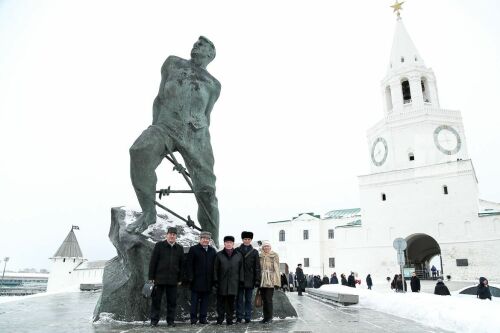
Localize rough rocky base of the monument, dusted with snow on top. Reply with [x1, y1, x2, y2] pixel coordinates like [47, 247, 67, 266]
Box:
[93, 207, 297, 321]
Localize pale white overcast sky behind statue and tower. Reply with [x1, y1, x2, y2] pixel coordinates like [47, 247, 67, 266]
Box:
[0, 0, 500, 269]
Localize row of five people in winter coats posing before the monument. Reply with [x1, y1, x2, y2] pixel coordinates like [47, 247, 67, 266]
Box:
[149, 228, 281, 327]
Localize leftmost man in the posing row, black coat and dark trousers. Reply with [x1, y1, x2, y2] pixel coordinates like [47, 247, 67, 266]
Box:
[148, 228, 188, 327]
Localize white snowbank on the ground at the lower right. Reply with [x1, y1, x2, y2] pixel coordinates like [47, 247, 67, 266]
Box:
[320, 284, 500, 333]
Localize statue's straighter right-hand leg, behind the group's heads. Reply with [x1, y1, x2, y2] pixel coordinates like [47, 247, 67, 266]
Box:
[181, 136, 219, 244]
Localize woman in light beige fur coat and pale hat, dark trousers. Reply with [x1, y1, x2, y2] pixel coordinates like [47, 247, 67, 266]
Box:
[260, 241, 280, 324]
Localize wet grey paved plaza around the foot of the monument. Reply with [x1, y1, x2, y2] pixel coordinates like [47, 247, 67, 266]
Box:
[0, 293, 445, 333]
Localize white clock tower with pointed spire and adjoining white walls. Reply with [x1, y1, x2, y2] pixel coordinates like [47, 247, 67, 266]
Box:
[269, 18, 500, 281]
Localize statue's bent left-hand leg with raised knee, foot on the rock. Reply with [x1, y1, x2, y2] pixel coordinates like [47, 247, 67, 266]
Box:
[127, 125, 167, 232]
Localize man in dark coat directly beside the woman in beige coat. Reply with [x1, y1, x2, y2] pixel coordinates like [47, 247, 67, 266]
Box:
[236, 231, 261, 323]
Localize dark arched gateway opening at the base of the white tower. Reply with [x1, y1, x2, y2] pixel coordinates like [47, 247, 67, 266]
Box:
[405, 234, 443, 279]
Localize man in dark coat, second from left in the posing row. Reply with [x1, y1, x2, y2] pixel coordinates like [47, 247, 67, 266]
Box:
[186, 231, 216, 325]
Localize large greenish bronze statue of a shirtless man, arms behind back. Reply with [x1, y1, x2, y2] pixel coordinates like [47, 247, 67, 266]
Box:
[127, 36, 221, 242]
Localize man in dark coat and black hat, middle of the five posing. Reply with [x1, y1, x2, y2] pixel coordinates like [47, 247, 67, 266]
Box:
[214, 236, 245, 325]
